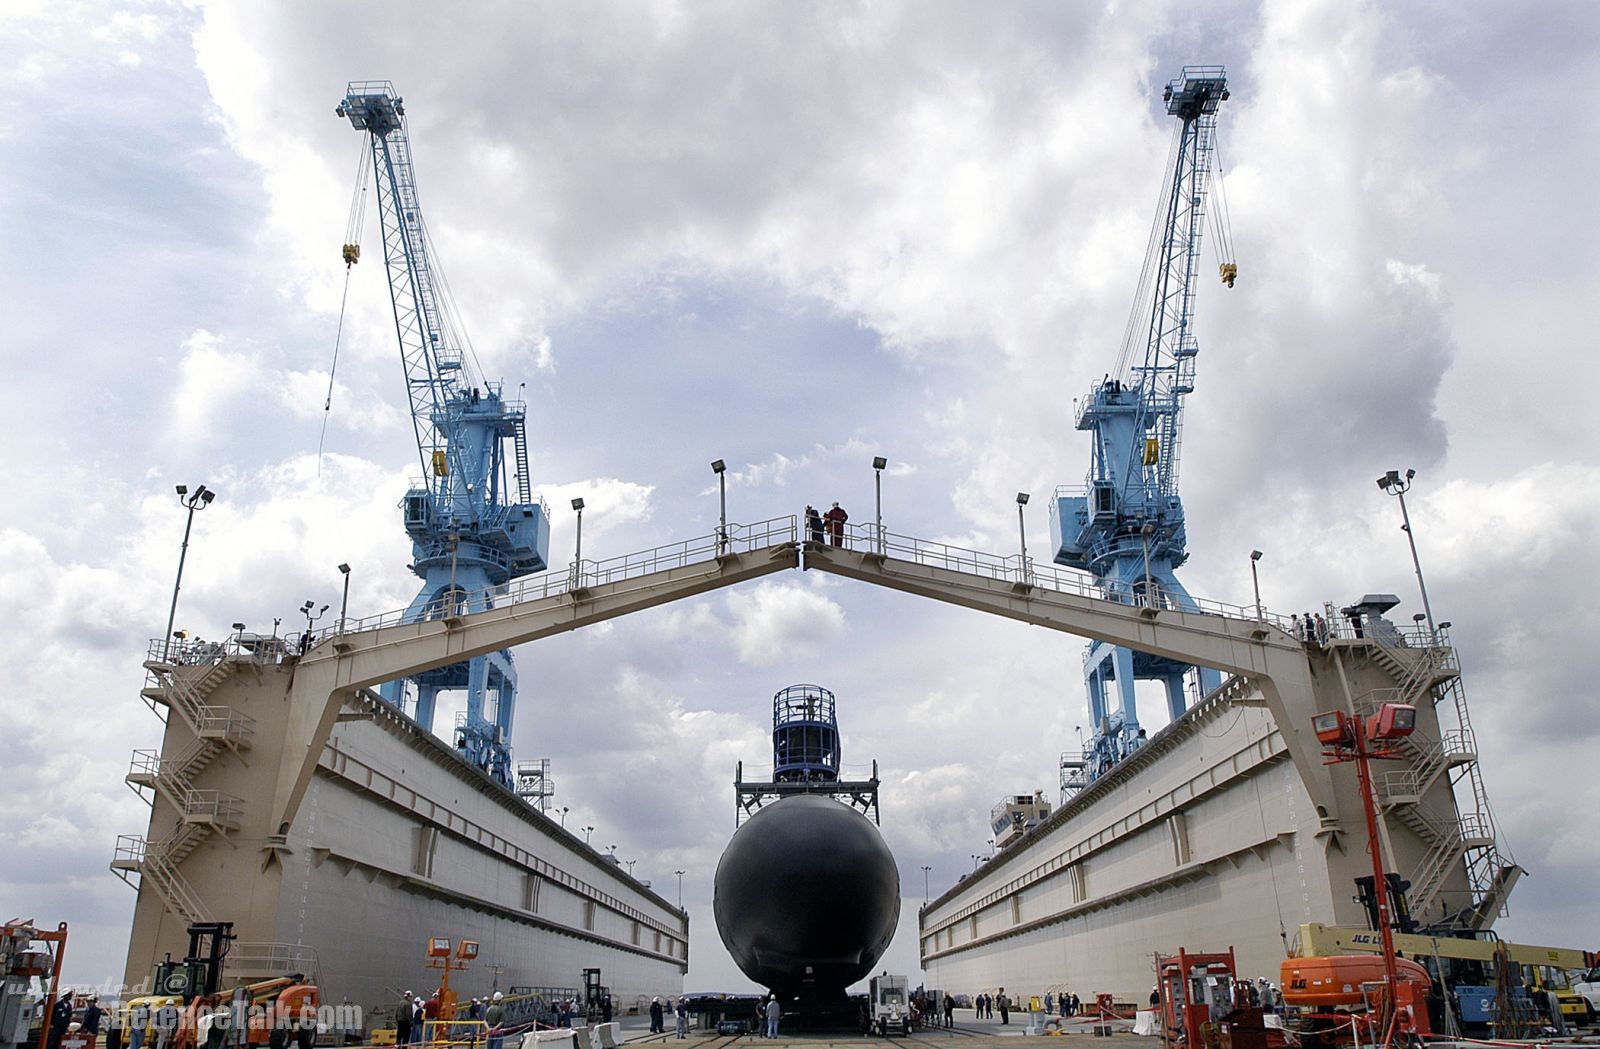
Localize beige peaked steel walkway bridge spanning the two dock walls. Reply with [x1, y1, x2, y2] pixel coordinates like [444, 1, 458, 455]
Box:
[272, 517, 1339, 850]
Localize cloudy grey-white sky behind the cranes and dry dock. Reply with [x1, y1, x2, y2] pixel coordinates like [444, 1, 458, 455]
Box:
[0, 0, 1600, 988]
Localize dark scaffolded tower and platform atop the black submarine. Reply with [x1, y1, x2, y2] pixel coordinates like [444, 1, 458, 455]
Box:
[733, 684, 882, 827]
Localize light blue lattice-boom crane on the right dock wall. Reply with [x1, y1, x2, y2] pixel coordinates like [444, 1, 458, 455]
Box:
[1051, 66, 1238, 780]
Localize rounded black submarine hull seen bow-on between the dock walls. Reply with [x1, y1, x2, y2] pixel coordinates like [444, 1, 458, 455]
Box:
[712, 795, 901, 999]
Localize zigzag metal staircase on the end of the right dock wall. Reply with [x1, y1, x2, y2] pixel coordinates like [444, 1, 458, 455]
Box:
[1357, 635, 1522, 932]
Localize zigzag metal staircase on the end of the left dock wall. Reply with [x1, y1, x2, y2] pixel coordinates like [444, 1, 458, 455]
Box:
[110, 644, 254, 924]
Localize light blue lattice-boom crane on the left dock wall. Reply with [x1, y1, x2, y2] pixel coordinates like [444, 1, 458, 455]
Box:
[338, 80, 550, 787]
